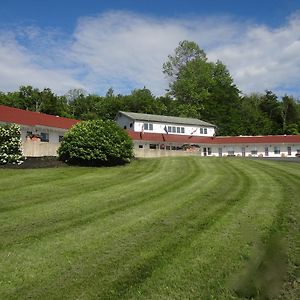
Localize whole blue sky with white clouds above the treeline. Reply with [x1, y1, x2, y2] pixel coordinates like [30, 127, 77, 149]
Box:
[0, 0, 300, 98]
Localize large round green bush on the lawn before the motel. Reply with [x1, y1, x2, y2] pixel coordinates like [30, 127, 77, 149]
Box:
[58, 120, 133, 166]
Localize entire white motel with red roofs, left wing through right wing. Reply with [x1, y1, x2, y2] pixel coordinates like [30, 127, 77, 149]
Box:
[0, 105, 300, 157]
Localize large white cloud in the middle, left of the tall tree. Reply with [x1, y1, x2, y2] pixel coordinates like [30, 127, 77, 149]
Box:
[70, 12, 241, 94]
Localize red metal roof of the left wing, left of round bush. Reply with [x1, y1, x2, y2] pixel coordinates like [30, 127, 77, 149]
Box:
[0, 105, 79, 129]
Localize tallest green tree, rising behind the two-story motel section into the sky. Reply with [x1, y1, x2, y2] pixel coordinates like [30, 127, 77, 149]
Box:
[163, 41, 241, 135]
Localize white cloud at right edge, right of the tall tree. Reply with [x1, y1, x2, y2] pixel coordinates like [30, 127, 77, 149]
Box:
[209, 15, 300, 95]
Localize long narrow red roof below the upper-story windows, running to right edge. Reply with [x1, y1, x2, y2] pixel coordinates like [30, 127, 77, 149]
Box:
[127, 130, 300, 144]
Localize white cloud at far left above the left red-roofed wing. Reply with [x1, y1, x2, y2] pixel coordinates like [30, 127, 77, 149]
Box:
[0, 32, 82, 94]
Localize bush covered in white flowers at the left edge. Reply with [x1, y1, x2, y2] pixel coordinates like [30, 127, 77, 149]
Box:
[0, 124, 24, 165]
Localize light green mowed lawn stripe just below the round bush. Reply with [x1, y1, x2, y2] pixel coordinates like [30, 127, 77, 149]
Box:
[0, 161, 162, 212]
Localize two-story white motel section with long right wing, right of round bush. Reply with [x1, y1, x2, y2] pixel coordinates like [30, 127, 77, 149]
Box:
[116, 111, 300, 157]
